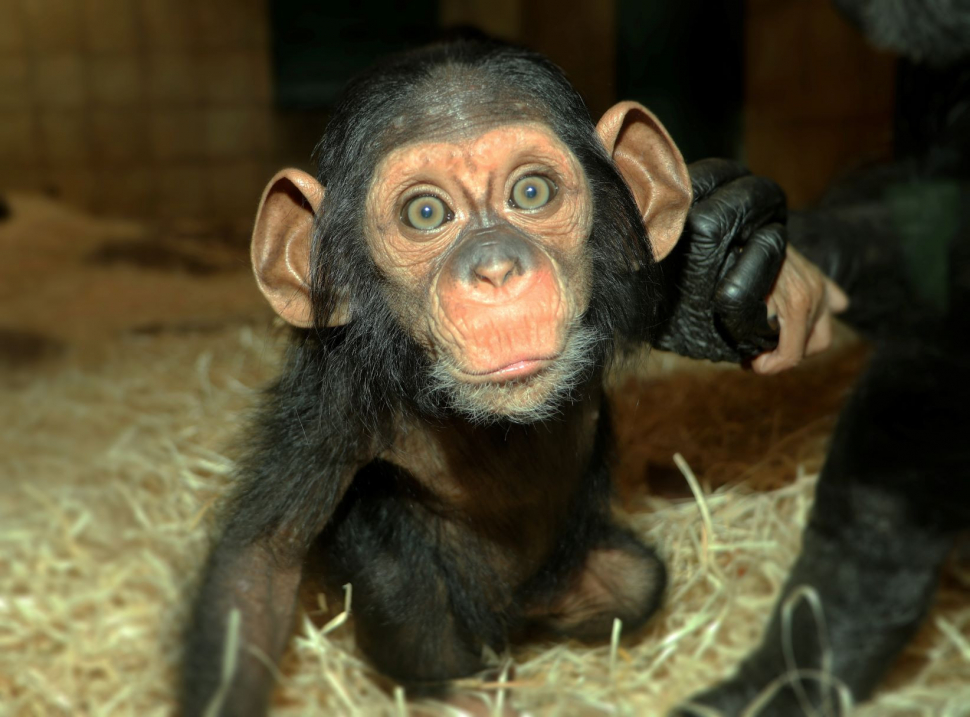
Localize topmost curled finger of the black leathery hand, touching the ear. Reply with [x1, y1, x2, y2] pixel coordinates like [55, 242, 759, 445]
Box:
[687, 175, 787, 248]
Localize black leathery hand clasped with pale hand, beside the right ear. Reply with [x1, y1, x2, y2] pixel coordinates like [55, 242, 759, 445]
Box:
[654, 159, 847, 373]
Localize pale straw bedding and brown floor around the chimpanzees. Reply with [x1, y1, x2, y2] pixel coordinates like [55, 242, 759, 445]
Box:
[0, 197, 970, 717]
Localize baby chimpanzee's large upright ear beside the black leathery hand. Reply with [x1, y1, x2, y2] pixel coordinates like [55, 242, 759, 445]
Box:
[596, 102, 691, 261]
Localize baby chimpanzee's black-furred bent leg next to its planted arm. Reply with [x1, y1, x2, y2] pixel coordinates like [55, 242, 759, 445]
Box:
[323, 463, 506, 694]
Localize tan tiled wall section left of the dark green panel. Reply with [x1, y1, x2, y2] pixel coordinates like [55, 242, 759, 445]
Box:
[0, 0, 271, 220]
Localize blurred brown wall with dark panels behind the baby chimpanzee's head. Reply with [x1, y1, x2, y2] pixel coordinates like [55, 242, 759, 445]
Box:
[0, 0, 893, 226]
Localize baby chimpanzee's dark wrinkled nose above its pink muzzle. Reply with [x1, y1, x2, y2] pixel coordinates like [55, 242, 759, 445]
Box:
[448, 227, 535, 289]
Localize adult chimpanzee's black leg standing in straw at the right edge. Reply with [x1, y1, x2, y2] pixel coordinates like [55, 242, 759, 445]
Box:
[680, 342, 970, 715]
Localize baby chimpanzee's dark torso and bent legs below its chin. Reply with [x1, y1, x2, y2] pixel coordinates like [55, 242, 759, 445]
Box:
[321, 398, 664, 691]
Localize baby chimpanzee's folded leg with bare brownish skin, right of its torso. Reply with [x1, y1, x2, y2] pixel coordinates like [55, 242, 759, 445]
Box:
[528, 523, 666, 640]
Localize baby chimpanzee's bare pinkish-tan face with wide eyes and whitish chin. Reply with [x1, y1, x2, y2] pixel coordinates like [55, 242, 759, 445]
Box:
[365, 122, 593, 418]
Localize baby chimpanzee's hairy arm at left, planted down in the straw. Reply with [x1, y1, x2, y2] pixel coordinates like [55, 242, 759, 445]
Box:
[182, 378, 359, 717]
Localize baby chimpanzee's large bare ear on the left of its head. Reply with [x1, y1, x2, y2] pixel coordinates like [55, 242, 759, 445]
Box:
[251, 169, 349, 328]
